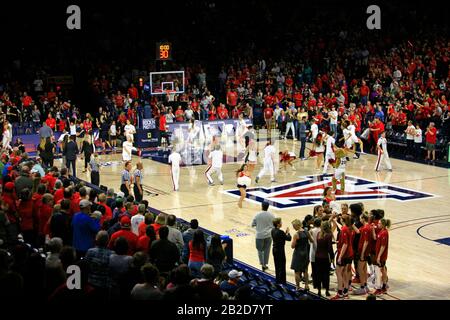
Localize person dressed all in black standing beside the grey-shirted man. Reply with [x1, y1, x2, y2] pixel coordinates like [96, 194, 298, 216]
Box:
[272, 218, 292, 284]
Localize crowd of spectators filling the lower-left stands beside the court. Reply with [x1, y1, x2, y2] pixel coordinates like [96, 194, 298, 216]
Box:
[0, 148, 264, 301]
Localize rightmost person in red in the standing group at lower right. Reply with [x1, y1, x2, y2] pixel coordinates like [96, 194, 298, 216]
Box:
[375, 218, 391, 295]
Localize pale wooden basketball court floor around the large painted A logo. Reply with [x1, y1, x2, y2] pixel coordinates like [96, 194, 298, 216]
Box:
[71, 140, 450, 300]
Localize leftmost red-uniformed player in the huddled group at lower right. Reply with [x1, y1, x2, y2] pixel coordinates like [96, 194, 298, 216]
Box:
[331, 215, 353, 300]
